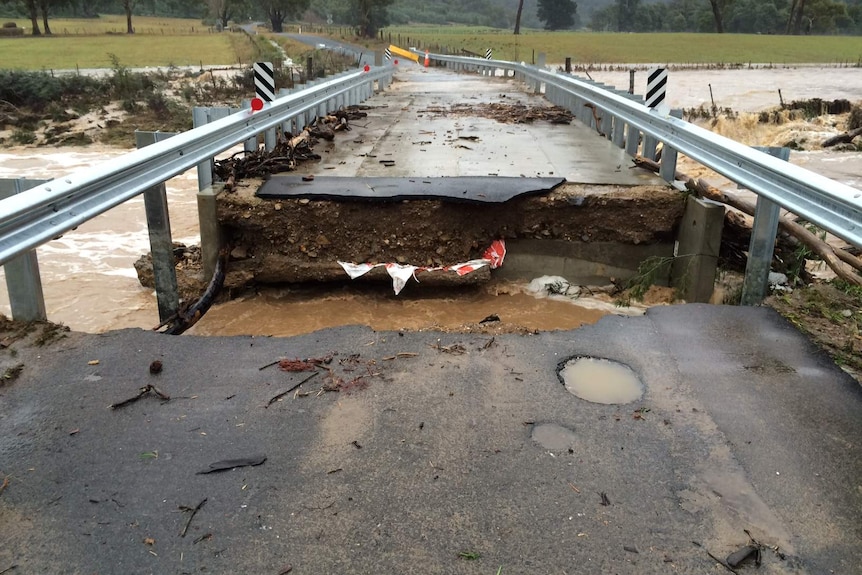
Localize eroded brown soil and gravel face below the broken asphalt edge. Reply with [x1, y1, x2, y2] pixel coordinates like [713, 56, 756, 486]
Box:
[213, 183, 684, 283]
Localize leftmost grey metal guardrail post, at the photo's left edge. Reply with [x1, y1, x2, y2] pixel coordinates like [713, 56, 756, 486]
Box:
[0, 179, 48, 321]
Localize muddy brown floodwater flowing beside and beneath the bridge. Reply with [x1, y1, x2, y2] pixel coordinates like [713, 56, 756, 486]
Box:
[0, 68, 862, 335]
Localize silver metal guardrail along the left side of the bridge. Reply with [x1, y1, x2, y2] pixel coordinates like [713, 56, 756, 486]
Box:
[0, 66, 393, 264]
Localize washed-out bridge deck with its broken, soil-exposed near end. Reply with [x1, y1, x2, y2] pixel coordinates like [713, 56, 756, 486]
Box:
[154, 68, 704, 310]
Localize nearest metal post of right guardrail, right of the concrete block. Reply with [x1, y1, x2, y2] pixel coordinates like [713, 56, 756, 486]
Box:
[739, 147, 790, 305]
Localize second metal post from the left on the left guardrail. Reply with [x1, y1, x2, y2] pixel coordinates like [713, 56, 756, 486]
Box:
[135, 131, 180, 321]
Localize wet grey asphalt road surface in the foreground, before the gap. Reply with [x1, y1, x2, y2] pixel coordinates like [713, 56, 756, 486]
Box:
[0, 305, 862, 574]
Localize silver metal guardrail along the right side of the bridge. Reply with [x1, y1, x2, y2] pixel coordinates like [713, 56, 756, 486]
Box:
[423, 53, 862, 251]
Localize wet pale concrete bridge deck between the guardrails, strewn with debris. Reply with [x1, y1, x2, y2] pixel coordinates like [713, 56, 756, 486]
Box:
[288, 62, 661, 186]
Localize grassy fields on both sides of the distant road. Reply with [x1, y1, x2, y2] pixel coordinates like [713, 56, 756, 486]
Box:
[0, 15, 862, 70]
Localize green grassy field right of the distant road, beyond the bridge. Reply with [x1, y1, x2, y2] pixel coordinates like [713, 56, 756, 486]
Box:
[384, 27, 862, 65]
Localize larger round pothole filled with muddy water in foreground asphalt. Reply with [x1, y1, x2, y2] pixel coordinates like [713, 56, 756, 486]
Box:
[559, 357, 644, 404]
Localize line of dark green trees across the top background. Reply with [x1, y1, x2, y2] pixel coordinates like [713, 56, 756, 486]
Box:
[0, 0, 862, 38]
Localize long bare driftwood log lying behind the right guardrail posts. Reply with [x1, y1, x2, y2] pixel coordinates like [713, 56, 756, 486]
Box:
[632, 156, 862, 286]
